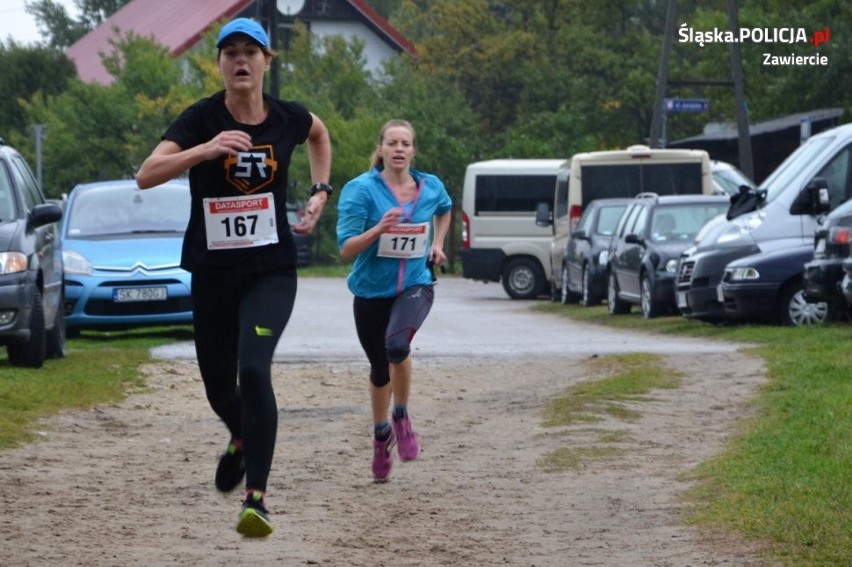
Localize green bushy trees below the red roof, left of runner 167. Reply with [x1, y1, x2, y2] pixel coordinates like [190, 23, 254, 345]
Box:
[13, 34, 201, 197]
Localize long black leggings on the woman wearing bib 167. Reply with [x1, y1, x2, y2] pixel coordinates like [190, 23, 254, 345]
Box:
[192, 270, 296, 490]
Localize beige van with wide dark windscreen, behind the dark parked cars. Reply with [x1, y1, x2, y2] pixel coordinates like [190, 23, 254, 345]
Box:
[535, 145, 719, 299]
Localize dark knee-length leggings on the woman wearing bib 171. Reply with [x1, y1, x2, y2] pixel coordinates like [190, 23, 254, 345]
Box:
[353, 285, 435, 388]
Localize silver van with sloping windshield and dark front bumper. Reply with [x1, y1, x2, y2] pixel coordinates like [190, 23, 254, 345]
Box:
[676, 124, 852, 322]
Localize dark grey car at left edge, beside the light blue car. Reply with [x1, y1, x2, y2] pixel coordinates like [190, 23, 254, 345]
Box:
[0, 140, 65, 368]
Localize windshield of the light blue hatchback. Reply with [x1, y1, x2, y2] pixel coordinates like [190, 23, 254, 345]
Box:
[68, 185, 190, 238]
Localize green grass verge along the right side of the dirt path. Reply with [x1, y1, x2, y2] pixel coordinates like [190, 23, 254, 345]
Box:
[537, 303, 852, 565]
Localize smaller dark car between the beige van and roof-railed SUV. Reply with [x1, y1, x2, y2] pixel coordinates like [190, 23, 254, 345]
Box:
[561, 199, 630, 307]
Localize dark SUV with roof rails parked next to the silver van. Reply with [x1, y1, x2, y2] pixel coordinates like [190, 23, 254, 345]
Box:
[607, 193, 730, 318]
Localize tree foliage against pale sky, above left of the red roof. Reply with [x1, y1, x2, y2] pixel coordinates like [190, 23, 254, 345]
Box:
[25, 0, 130, 48]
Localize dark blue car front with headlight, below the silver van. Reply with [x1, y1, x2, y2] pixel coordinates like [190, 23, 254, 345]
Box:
[717, 241, 833, 326]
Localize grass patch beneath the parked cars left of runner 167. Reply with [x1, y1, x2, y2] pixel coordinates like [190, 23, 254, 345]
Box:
[0, 327, 192, 449]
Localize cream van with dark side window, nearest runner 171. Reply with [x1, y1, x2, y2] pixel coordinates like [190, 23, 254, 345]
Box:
[459, 159, 564, 299]
